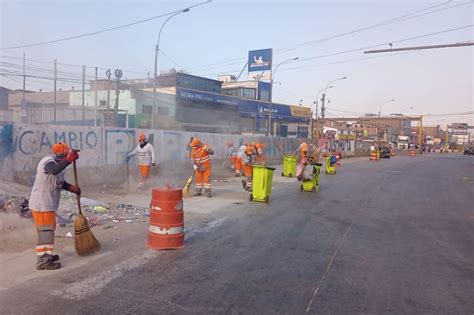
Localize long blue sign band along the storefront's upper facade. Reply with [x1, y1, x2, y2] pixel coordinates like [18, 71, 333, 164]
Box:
[176, 88, 309, 123]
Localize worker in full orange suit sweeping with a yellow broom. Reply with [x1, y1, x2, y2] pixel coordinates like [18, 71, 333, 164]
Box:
[190, 138, 214, 198]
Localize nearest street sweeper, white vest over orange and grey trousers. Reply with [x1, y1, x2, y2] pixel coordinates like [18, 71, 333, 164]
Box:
[29, 142, 81, 270]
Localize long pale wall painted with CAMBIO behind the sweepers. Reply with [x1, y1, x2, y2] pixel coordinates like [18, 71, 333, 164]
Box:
[0, 123, 298, 183]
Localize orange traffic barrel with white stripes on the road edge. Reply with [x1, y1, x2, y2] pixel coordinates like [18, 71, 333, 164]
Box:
[148, 188, 184, 249]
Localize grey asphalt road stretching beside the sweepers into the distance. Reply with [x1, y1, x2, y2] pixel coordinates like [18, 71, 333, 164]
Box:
[0, 154, 474, 314]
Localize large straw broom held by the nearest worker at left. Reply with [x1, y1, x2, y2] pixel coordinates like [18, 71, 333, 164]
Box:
[72, 161, 100, 256]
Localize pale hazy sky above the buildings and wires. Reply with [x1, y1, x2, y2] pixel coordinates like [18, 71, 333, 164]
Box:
[0, 0, 474, 125]
